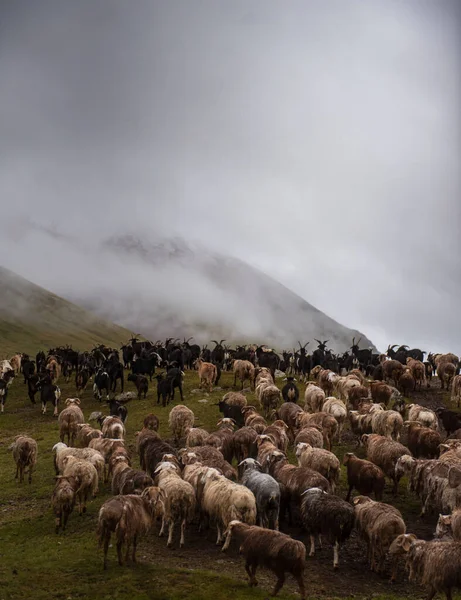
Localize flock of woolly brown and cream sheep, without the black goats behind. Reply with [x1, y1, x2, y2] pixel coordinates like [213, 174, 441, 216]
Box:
[6, 354, 461, 599]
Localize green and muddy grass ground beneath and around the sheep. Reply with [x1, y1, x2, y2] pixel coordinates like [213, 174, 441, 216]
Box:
[0, 364, 448, 600]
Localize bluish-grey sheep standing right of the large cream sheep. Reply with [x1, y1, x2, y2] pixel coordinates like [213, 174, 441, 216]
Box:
[239, 458, 280, 530]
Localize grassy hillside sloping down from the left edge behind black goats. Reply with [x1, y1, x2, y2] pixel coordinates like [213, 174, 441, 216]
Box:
[0, 267, 135, 356]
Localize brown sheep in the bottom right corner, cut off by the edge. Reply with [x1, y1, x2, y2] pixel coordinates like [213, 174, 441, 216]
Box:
[404, 540, 461, 600]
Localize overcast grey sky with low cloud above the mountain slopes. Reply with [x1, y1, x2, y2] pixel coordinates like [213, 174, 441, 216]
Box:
[0, 0, 461, 353]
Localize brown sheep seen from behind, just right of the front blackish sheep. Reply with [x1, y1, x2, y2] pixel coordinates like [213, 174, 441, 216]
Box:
[353, 496, 406, 573]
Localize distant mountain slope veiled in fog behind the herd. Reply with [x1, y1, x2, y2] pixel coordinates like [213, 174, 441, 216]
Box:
[70, 235, 374, 352]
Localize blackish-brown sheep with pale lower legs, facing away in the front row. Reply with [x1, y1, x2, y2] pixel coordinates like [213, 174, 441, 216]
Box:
[301, 488, 355, 569]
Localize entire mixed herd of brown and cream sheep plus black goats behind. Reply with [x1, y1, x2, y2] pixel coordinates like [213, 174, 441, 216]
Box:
[4, 337, 461, 600]
